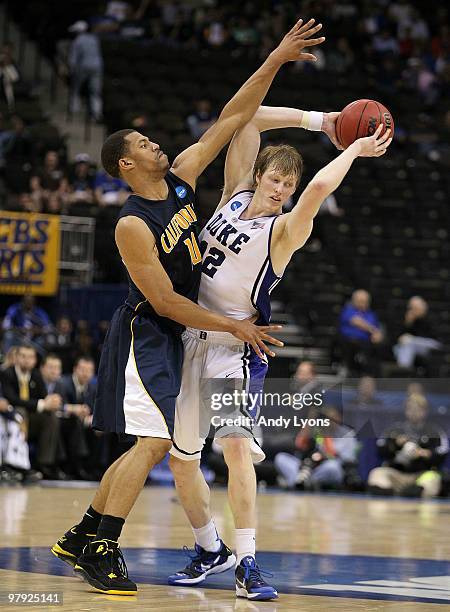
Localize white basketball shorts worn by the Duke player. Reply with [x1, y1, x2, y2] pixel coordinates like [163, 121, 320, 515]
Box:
[169, 328, 268, 463]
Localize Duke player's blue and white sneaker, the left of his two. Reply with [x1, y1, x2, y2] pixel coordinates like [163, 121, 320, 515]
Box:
[168, 540, 236, 586]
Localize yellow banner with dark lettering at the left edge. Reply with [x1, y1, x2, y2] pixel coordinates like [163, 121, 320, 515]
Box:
[0, 210, 60, 295]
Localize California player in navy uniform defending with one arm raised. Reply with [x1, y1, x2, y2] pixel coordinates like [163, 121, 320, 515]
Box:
[52, 20, 324, 595]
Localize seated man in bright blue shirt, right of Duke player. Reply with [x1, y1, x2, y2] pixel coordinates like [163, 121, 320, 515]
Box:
[339, 289, 383, 376]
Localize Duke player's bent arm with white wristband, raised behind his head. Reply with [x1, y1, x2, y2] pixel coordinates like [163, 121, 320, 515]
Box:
[217, 106, 342, 210]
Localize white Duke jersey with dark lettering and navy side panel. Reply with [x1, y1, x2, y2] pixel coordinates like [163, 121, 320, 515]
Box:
[198, 190, 281, 325]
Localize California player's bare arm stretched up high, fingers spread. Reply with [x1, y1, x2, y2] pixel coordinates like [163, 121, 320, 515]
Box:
[172, 19, 325, 187]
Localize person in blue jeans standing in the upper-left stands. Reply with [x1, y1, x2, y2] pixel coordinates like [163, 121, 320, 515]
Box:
[69, 19, 103, 121]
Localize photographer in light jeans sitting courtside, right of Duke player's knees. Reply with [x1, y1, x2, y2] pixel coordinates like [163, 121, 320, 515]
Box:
[275, 406, 358, 489]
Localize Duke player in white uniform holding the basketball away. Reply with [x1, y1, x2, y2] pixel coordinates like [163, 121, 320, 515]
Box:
[169, 107, 391, 600]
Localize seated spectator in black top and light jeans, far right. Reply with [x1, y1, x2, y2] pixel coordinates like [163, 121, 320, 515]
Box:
[393, 295, 442, 368]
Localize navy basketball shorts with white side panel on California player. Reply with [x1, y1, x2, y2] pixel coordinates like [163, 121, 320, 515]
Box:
[93, 305, 183, 439]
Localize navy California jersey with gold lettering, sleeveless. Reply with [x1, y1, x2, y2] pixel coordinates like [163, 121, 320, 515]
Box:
[119, 172, 201, 331]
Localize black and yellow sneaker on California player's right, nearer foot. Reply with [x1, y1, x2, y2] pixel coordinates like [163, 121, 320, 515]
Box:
[74, 540, 137, 595]
